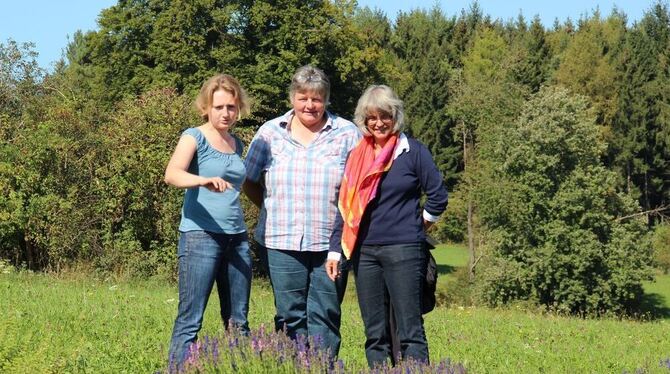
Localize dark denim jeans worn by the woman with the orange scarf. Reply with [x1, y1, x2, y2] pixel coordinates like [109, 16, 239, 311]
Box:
[353, 243, 428, 367]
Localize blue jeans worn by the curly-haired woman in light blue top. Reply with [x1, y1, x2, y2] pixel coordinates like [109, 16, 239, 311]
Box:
[169, 231, 251, 365]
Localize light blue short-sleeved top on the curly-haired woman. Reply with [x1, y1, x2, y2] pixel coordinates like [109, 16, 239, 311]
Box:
[179, 128, 246, 234]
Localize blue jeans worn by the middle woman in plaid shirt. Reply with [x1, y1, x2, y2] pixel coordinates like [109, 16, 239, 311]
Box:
[268, 249, 346, 357]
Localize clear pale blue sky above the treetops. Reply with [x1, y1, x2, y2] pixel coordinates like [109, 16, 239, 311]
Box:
[0, 0, 654, 68]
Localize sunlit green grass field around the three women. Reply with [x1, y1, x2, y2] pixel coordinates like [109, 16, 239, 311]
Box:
[0, 246, 670, 373]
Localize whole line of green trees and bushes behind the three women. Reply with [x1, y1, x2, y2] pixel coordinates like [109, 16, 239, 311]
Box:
[0, 0, 670, 314]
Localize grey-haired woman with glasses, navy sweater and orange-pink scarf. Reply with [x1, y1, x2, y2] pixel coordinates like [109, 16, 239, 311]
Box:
[326, 85, 447, 367]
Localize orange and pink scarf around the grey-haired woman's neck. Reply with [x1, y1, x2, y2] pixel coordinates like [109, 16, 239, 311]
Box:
[338, 134, 398, 258]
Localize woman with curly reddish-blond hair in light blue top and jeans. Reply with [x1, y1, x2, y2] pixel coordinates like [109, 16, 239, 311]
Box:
[165, 74, 251, 368]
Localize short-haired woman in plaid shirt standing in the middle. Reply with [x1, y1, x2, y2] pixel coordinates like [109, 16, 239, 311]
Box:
[244, 65, 361, 357]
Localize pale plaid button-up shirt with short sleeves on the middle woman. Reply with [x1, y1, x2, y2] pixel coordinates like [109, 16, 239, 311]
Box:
[244, 111, 361, 251]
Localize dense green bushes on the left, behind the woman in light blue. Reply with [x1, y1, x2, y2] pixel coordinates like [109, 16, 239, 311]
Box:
[0, 82, 272, 278]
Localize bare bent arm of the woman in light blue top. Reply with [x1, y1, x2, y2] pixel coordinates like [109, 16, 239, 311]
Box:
[164, 135, 232, 192]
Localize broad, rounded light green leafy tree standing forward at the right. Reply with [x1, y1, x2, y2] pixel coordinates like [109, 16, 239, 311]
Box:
[476, 87, 651, 315]
